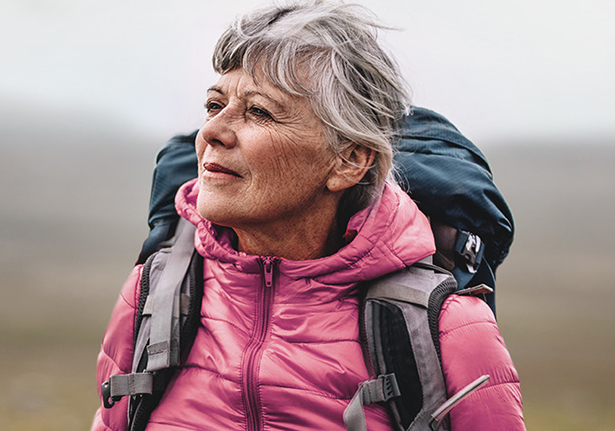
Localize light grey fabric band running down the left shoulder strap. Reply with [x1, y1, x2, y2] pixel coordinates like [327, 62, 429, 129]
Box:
[146, 218, 194, 372]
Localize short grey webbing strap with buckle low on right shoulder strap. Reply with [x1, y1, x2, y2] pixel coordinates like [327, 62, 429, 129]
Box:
[344, 374, 401, 431]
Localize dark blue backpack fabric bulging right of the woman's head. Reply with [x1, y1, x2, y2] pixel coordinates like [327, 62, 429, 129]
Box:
[395, 108, 514, 310]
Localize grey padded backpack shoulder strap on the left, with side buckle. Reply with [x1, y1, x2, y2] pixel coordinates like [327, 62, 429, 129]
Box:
[103, 219, 203, 430]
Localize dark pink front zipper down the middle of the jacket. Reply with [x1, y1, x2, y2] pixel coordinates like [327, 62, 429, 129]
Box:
[243, 256, 276, 431]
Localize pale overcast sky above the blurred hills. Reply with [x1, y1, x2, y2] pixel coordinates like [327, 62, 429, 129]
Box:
[0, 0, 615, 145]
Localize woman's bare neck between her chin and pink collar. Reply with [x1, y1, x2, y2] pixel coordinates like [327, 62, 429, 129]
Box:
[233, 203, 342, 260]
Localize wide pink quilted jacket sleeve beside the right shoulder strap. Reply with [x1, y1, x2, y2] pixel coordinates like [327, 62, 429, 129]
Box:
[439, 295, 525, 431]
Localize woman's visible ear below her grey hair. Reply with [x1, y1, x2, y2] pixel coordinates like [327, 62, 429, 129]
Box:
[326, 144, 376, 192]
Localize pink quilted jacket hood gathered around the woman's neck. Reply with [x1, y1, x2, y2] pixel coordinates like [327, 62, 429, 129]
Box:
[175, 179, 435, 285]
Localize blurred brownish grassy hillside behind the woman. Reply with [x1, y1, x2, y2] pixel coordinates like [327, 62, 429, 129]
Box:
[0, 116, 615, 431]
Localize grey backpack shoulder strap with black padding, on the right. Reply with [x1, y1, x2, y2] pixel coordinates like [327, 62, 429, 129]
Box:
[344, 261, 457, 431]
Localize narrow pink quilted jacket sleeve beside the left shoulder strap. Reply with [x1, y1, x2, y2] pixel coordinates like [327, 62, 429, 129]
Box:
[91, 265, 142, 431]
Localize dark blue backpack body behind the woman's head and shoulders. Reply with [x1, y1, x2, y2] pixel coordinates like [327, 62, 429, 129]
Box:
[137, 107, 514, 314]
